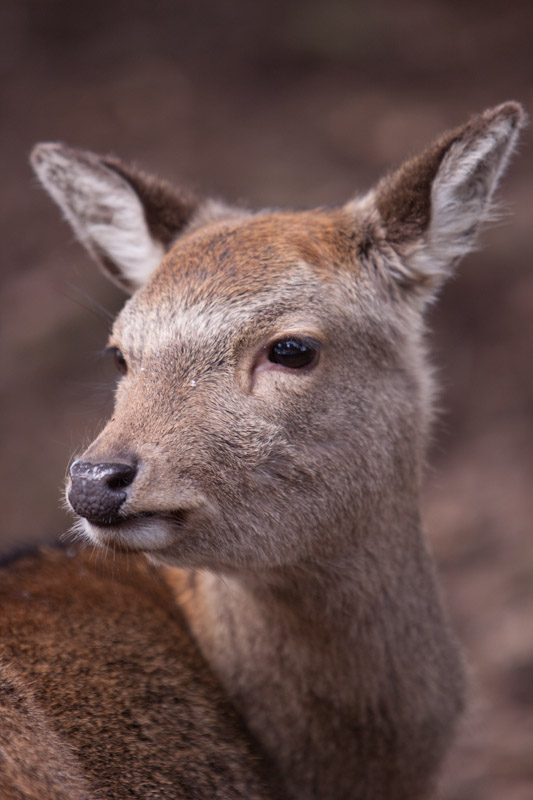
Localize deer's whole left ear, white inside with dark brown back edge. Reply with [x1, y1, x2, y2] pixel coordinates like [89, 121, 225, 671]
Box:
[31, 143, 198, 292]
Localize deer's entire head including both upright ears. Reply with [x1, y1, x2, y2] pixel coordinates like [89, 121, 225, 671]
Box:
[33, 103, 523, 570]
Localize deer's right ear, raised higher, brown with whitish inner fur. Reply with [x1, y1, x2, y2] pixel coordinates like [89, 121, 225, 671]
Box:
[356, 102, 525, 294]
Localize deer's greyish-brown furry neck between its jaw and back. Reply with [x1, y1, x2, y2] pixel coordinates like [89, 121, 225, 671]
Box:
[167, 510, 461, 800]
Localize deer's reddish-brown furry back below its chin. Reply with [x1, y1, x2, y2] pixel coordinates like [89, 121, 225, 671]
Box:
[0, 551, 271, 800]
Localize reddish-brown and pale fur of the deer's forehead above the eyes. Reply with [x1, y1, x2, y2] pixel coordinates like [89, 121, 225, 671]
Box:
[114, 209, 370, 353]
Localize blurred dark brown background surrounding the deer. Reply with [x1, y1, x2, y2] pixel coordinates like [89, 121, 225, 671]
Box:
[0, 0, 533, 800]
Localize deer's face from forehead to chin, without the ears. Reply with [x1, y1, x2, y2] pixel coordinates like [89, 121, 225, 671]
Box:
[69, 212, 419, 568]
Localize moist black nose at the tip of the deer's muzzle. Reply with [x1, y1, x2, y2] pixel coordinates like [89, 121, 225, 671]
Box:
[68, 461, 137, 525]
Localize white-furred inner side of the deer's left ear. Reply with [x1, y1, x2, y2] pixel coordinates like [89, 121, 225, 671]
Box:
[31, 143, 165, 289]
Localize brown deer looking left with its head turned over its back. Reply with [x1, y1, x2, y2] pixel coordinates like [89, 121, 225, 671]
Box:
[0, 102, 525, 800]
